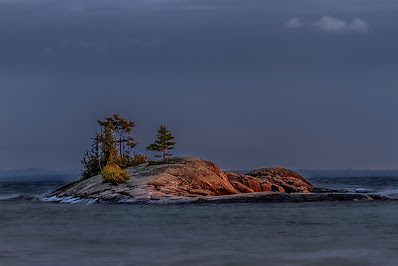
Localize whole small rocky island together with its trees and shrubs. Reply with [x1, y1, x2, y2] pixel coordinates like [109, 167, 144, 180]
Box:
[43, 114, 384, 203]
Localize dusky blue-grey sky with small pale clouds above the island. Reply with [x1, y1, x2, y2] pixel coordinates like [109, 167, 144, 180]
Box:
[0, 0, 398, 169]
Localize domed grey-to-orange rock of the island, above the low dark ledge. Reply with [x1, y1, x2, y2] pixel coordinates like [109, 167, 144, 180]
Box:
[46, 156, 313, 202]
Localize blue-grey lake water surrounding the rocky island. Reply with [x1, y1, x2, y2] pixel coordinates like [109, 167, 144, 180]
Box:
[0, 178, 398, 265]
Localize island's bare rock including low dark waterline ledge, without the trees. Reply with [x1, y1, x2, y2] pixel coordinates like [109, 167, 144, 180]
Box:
[43, 156, 386, 203]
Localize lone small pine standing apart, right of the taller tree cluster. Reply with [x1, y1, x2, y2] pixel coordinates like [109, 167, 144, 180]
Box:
[146, 125, 175, 163]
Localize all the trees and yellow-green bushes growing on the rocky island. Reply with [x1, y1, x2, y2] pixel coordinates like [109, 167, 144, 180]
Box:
[82, 114, 175, 182]
